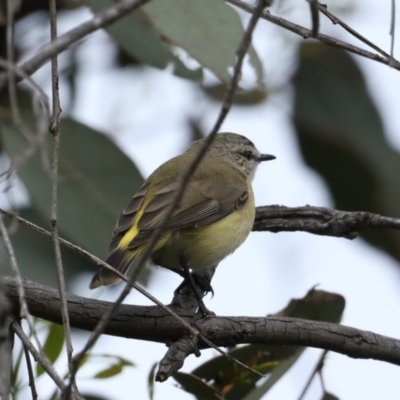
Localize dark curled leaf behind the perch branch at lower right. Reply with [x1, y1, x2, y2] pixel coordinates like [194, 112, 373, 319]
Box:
[174, 289, 345, 400]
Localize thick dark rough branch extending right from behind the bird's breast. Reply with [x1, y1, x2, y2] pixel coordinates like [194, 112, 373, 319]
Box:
[253, 205, 400, 239]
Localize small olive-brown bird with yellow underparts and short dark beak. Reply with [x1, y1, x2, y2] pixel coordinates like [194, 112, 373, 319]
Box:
[90, 133, 275, 296]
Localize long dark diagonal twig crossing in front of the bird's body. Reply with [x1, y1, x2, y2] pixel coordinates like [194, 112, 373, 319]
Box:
[68, 0, 265, 384]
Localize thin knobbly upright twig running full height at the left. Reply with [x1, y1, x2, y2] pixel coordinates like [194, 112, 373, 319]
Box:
[49, 0, 79, 399]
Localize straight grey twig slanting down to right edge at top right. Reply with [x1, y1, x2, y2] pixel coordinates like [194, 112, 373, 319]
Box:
[225, 0, 400, 70]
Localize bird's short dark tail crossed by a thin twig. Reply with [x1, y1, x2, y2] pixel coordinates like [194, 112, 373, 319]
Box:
[89, 249, 137, 289]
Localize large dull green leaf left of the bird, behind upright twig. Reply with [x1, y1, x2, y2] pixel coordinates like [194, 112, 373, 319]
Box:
[1, 95, 150, 282]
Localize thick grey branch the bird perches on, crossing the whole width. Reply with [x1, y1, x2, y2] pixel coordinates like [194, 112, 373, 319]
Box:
[4, 278, 400, 365]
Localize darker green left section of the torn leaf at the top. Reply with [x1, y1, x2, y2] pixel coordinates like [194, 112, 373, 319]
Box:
[84, 0, 203, 81]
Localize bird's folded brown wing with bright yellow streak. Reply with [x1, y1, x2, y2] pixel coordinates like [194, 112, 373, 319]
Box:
[110, 172, 248, 250]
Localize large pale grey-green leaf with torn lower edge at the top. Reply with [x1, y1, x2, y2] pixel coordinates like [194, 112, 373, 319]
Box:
[85, 0, 263, 86]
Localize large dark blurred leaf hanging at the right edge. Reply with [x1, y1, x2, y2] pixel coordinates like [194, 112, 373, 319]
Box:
[293, 44, 400, 261]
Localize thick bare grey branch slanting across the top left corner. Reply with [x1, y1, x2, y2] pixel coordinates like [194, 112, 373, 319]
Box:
[0, 0, 150, 89]
